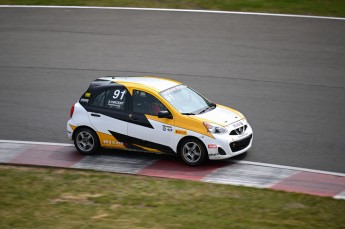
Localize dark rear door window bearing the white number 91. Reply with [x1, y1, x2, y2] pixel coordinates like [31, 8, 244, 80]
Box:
[105, 88, 127, 111]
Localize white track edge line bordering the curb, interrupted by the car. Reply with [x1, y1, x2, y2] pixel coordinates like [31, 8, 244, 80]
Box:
[0, 140, 345, 177]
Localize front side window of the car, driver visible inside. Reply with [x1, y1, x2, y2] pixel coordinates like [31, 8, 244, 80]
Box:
[133, 90, 168, 116]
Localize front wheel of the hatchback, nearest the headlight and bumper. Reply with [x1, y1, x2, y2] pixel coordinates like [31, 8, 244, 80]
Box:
[179, 138, 207, 166]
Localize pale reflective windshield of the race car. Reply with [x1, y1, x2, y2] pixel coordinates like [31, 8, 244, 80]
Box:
[160, 85, 215, 115]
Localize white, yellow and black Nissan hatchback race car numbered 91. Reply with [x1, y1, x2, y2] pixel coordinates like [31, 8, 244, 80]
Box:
[67, 77, 253, 166]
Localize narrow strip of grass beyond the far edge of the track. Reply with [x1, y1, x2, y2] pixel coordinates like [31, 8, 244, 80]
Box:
[0, 0, 345, 17]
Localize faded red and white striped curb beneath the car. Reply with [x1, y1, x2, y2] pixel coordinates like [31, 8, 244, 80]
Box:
[0, 140, 345, 199]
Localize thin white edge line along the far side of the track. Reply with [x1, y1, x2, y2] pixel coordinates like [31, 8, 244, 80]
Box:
[0, 5, 345, 20]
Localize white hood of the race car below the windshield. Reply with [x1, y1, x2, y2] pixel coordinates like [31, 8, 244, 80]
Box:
[189, 104, 244, 126]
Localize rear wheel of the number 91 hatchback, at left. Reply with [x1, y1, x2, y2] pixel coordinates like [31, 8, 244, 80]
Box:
[74, 128, 99, 155]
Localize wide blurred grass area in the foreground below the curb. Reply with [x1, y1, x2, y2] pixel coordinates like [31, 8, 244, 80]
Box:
[0, 166, 345, 229]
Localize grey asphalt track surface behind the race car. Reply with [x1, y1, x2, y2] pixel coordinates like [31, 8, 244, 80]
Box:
[0, 8, 345, 173]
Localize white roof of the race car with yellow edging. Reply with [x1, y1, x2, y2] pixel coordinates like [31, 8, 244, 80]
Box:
[97, 76, 182, 92]
